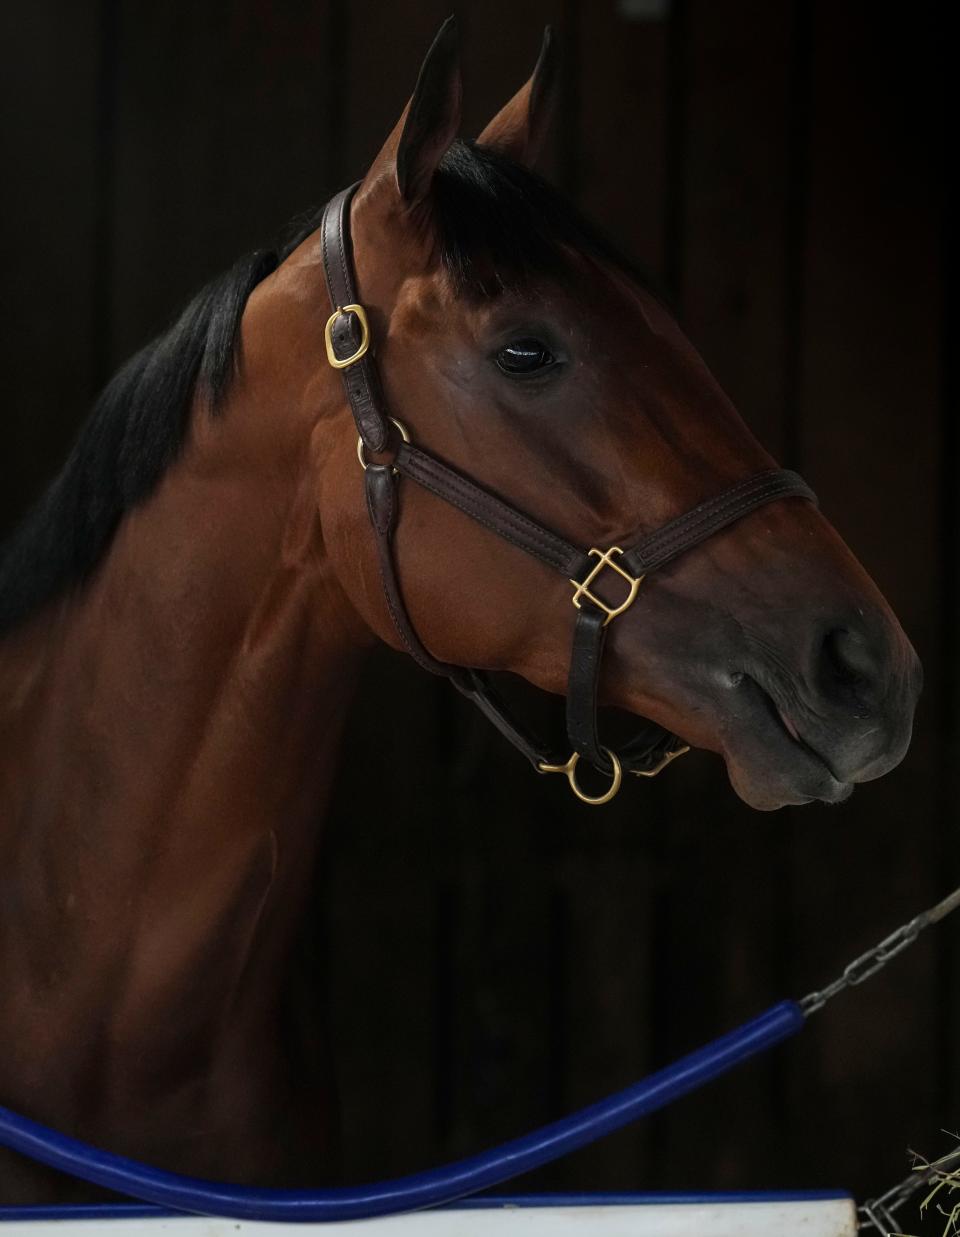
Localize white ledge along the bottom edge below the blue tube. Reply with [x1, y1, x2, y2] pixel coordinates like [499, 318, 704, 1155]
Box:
[0, 1199, 856, 1237]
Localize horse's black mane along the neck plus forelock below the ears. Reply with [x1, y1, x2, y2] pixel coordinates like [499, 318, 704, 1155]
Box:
[0, 142, 648, 635]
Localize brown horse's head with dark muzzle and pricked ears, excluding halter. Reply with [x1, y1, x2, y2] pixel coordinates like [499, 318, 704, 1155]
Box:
[258, 24, 920, 809]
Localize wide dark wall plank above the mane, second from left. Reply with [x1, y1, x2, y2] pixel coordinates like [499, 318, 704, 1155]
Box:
[110, 0, 341, 362]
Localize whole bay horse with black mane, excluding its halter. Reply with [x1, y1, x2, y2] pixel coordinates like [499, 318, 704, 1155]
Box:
[0, 22, 919, 1202]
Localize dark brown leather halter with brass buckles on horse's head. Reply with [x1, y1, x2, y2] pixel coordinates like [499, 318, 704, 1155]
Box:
[320, 184, 816, 804]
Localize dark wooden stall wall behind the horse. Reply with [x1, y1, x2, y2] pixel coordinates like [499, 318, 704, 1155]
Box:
[0, 0, 960, 1228]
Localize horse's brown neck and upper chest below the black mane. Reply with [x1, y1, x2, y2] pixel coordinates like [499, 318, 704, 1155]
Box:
[0, 376, 365, 1093]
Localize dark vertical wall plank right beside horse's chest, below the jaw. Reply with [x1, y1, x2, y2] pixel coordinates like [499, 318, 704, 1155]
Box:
[315, 653, 448, 1180]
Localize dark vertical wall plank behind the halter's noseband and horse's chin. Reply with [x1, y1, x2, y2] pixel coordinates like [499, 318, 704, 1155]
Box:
[654, 0, 794, 1189]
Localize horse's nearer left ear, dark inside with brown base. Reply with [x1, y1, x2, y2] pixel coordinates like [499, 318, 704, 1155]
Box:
[367, 17, 463, 205]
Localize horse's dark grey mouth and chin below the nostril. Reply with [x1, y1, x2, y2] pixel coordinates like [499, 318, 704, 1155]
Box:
[722, 674, 854, 811]
